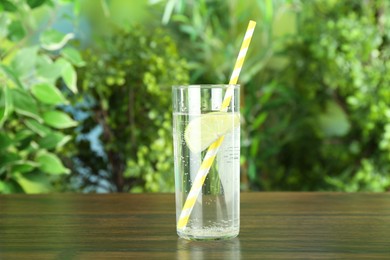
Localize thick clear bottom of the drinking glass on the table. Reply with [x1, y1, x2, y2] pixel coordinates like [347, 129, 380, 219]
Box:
[177, 228, 239, 241]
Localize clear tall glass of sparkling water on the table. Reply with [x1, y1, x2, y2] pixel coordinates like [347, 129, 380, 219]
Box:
[172, 85, 240, 240]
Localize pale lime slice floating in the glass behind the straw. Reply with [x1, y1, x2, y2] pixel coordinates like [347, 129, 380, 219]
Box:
[184, 112, 240, 153]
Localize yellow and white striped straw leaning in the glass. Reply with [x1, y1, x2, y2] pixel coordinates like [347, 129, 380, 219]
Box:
[177, 21, 256, 229]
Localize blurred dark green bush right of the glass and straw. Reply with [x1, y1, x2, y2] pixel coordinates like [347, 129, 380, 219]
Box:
[250, 1, 390, 191]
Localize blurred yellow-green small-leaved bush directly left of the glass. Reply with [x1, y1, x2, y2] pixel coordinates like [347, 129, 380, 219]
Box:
[75, 27, 188, 192]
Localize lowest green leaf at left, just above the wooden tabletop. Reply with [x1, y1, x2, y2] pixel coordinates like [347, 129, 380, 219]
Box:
[15, 172, 51, 194]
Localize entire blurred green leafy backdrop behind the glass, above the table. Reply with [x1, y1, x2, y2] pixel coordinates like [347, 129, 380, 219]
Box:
[0, 0, 390, 193]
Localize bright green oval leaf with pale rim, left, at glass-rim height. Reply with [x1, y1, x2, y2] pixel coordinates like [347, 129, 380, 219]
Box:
[31, 83, 67, 105]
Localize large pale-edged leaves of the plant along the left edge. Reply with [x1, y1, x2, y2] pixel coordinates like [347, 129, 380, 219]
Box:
[0, 0, 81, 193]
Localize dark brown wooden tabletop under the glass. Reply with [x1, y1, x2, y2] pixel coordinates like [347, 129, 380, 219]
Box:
[0, 193, 390, 259]
